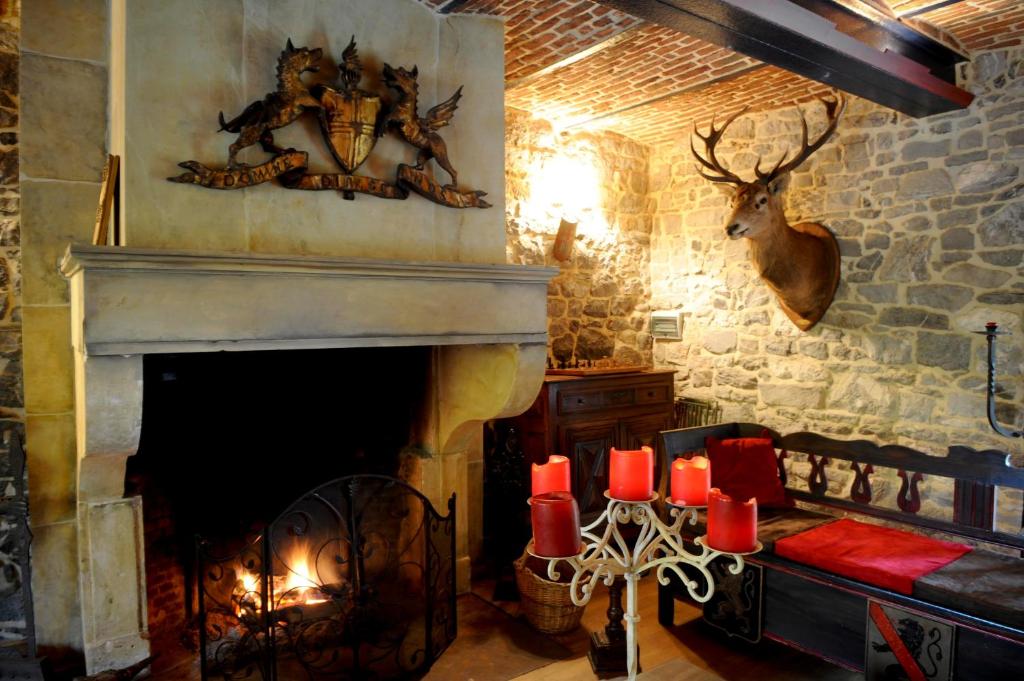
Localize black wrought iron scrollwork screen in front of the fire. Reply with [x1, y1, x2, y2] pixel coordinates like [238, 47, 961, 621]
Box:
[197, 475, 456, 681]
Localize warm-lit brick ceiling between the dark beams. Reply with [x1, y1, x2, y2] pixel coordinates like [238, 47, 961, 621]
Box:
[420, 0, 1024, 144]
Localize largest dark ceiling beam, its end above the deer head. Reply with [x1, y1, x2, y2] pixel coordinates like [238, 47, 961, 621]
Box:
[597, 0, 974, 117]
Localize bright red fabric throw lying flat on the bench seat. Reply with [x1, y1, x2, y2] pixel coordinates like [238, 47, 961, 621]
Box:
[775, 518, 971, 596]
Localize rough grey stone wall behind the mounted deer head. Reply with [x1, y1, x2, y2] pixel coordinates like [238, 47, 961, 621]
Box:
[650, 48, 1024, 526]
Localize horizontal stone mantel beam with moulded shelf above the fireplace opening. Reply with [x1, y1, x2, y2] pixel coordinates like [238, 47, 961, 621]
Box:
[60, 246, 557, 355]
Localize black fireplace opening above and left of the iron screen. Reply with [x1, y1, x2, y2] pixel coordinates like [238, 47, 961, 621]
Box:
[126, 347, 431, 672]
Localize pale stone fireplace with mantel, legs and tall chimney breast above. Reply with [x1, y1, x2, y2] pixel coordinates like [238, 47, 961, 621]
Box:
[27, 0, 553, 672]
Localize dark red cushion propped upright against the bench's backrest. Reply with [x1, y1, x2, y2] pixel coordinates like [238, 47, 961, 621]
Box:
[705, 437, 793, 507]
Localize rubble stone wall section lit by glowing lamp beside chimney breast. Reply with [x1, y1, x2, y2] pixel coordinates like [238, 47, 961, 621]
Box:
[505, 109, 651, 365]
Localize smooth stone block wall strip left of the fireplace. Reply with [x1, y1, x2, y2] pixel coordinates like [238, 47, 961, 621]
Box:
[20, 0, 108, 668]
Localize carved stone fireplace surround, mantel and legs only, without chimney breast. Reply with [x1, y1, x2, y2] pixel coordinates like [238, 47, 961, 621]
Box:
[60, 246, 557, 673]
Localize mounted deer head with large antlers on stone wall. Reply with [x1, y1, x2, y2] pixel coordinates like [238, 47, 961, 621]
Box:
[690, 95, 846, 331]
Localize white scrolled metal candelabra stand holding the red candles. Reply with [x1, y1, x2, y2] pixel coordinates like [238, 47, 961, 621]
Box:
[526, 492, 762, 681]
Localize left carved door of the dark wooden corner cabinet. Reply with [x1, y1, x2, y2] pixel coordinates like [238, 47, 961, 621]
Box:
[559, 421, 618, 516]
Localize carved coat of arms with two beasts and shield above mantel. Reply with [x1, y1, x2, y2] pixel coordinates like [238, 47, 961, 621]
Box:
[168, 37, 490, 208]
